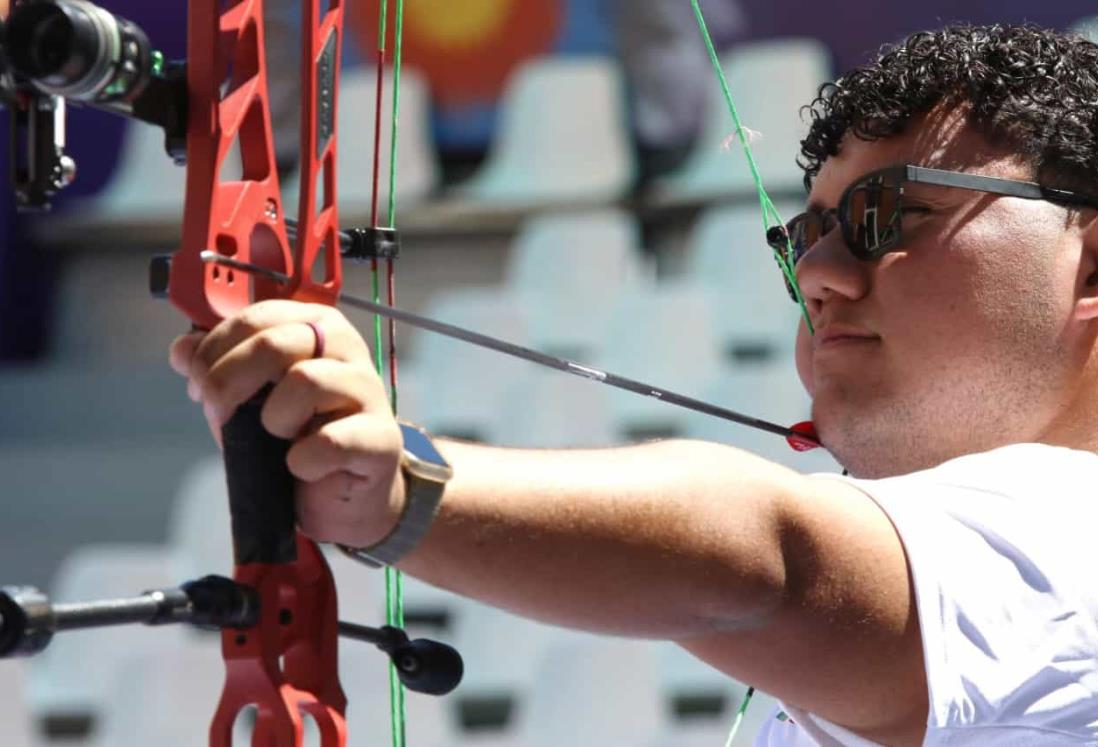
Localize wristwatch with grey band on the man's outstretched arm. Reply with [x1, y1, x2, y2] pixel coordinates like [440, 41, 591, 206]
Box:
[339, 422, 453, 568]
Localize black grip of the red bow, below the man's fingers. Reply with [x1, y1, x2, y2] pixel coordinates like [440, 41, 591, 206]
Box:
[221, 386, 298, 565]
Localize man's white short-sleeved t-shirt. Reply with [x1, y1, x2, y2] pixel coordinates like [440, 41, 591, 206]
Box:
[755, 444, 1098, 747]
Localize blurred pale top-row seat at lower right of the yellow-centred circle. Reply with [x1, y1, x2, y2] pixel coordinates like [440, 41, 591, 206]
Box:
[457, 57, 634, 208]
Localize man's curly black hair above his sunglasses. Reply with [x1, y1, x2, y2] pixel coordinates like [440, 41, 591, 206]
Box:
[798, 24, 1098, 193]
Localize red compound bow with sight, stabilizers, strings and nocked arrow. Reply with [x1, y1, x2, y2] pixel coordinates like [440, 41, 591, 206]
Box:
[0, 0, 816, 747]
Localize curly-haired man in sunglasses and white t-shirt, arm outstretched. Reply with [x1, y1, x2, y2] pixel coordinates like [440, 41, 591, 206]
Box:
[172, 21, 1098, 746]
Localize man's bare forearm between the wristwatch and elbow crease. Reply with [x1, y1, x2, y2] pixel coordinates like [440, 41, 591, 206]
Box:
[400, 441, 803, 638]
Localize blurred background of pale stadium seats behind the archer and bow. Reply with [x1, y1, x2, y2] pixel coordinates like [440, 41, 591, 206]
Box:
[0, 0, 1093, 747]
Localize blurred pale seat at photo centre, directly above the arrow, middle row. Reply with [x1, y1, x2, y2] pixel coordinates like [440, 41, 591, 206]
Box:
[505, 209, 647, 358]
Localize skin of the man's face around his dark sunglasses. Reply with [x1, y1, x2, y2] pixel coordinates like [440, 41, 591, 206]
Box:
[797, 115, 1094, 477]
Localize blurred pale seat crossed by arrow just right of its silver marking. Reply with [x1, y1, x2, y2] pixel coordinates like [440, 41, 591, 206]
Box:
[594, 283, 720, 441]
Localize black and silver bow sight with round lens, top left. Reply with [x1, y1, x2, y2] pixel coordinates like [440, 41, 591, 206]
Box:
[0, 0, 187, 210]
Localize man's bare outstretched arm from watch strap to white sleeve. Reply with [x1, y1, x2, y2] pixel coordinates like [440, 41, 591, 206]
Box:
[401, 442, 927, 744]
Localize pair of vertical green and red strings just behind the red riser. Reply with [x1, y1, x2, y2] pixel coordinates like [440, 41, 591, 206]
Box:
[370, 0, 406, 747]
